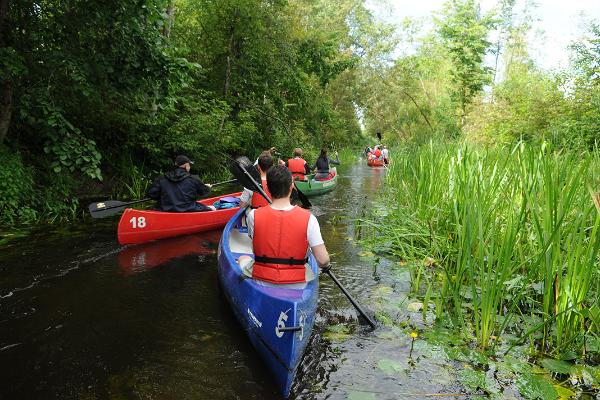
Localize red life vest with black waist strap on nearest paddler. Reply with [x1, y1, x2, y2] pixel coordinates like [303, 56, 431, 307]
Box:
[252, 207, 310, 284]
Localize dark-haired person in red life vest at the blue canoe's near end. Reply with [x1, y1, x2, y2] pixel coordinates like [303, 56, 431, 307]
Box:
[238, 165, 329, 284]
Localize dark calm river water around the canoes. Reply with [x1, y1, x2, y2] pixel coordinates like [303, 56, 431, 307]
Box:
[0, 161, 457, 400]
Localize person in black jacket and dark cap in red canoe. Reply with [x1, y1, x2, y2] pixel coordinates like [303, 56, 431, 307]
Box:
[148, 155, 215, 212]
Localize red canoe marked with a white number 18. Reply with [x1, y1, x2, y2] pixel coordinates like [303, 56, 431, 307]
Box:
[117, 192, 241, 244]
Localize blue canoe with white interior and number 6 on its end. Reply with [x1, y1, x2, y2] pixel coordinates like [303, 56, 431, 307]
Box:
[218, 210, 319, 397]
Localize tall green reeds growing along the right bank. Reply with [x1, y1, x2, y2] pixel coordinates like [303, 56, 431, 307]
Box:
[363, 143, 600, 360]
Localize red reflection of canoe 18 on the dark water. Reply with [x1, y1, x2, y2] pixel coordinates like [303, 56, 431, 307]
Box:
[117, 230, 222, 275]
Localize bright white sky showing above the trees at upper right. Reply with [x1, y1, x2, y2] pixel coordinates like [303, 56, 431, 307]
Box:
[367, 0, 600, 70]
